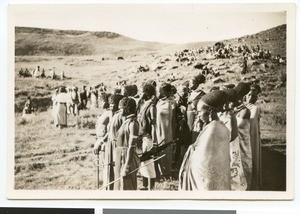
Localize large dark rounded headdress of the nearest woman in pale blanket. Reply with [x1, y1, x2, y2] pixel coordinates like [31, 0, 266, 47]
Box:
[200, 90, 227, 109]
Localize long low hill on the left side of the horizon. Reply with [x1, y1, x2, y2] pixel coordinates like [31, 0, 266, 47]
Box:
[15, 27, 176, 56]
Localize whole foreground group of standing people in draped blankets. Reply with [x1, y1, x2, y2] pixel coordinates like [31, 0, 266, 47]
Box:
[95, 75, 261, 190]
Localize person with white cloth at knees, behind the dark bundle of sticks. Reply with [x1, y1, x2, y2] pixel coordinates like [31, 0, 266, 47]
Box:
[137, 84, 157, 190]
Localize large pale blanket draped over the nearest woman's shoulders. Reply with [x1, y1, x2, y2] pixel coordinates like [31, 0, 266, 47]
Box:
[179, 121, 231, 190]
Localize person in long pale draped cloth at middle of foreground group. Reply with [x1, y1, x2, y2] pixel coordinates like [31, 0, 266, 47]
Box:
[156, 83, 175, 178]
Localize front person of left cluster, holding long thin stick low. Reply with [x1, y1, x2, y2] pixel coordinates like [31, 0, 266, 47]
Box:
[116, 98, 140, 190]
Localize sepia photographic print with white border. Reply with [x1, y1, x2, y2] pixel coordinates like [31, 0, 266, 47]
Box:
[7, 4, 295, 200]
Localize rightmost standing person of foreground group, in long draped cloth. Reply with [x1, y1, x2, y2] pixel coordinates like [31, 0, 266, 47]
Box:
[245, 84, 262, 190]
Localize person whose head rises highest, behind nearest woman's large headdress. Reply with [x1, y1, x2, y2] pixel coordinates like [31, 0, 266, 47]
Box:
[186, 74, 205, 144]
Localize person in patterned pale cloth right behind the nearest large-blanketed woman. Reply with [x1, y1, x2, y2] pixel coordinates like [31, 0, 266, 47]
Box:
[218, 88, 247, 191]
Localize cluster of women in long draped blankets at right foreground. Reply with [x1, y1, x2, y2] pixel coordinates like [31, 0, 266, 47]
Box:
[179, 83, 261, 191]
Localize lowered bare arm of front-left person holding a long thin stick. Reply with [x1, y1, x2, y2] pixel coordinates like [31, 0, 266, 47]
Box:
[121, 122, 139, 176]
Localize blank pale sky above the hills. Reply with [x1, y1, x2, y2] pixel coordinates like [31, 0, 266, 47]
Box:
[13, 4, 286, 43]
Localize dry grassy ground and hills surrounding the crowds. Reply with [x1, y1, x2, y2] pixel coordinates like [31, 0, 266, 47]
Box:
[15, 26, 286, 191]
